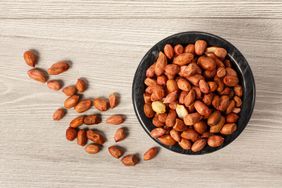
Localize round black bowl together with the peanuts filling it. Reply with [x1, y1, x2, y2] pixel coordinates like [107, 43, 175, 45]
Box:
[132, 32, 255, 155]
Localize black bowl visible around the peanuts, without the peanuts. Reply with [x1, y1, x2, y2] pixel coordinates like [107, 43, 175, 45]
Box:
[132, 31, 256, 155]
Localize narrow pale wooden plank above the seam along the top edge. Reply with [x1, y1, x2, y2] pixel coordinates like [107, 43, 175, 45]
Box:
[0, 0, 282, 19]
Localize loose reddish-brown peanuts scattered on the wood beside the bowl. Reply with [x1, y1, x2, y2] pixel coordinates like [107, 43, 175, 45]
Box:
[24, 50, 159, 166]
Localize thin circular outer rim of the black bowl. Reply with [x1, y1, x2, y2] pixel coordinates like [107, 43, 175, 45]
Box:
[132, 31, 256, 155]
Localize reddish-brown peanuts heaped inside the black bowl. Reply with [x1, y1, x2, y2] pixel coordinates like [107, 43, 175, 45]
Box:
[144, 40, 243, 152]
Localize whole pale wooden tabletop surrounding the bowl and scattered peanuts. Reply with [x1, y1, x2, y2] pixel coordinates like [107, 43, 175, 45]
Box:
[0, 0, 282, 188]
